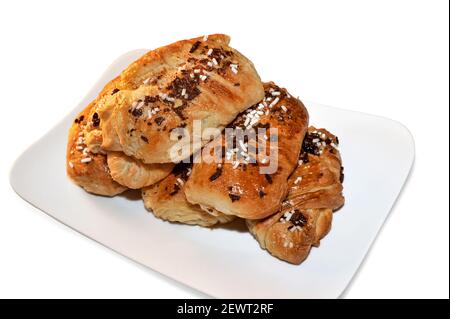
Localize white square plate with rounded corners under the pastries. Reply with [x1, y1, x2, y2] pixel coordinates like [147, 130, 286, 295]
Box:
[11, 50, 414, 298]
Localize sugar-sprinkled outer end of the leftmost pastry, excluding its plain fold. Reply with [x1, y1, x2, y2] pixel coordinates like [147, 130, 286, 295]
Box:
[66, 103, 127, 196]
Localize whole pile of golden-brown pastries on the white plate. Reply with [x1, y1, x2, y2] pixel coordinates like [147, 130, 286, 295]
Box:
[67, 34, 344, 264]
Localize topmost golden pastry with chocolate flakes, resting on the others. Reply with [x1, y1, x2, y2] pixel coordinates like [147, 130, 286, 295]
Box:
[99, 34, 264, 163]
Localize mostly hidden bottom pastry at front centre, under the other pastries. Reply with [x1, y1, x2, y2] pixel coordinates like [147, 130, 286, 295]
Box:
[142, 163, 234, 227]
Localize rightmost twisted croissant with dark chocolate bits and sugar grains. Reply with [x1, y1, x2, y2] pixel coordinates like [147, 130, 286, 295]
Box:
[246, 127, 344, 264]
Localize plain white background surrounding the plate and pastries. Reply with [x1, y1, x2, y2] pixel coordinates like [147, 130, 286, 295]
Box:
[0, 0, 449, 298]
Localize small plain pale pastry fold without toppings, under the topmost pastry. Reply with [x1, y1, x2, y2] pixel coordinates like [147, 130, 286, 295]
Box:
[107, 152, 174, 189]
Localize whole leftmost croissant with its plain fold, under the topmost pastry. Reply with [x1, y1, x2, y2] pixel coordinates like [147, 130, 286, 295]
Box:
[66, 84, 174, 196]
